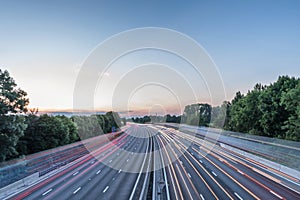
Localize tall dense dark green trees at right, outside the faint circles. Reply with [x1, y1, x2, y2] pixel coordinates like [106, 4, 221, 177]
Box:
[225, 76, 300, 141]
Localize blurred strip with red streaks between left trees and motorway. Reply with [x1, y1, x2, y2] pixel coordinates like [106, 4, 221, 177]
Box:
[0, 127, 126, 188]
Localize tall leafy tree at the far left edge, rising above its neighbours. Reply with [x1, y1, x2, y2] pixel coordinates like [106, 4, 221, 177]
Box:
[0, 69, 29, 162]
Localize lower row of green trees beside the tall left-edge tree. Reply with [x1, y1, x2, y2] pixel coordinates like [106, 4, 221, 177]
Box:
[14, 112, 122, 158]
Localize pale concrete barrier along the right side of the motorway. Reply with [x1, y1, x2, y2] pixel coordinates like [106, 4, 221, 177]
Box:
[220, 143, 300, 180]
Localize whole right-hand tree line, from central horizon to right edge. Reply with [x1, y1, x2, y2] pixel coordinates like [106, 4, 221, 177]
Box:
[132, 76, 300, 141]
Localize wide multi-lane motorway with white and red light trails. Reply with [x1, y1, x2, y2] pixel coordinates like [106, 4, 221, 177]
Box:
[7, 124, 300, 200]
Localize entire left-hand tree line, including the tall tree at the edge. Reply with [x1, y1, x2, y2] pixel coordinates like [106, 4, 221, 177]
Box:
[0, 69, 124, 162]
